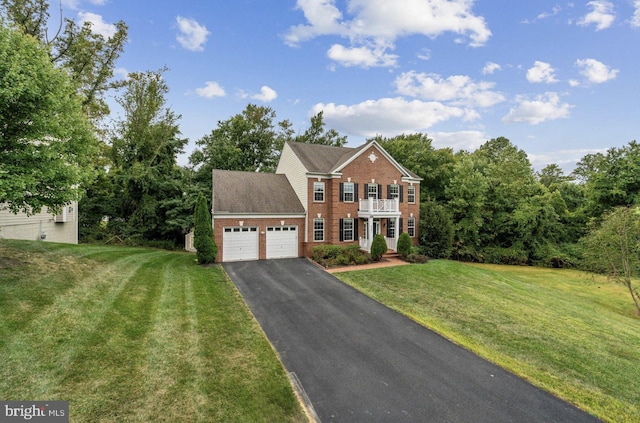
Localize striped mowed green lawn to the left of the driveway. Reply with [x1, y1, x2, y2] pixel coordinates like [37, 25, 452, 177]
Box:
[0, 240, 307, 423]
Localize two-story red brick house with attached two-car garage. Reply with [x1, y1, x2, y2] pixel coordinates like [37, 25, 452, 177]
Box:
[212, 141, 421, 261]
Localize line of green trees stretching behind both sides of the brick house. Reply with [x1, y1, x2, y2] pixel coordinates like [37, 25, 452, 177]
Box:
[0, 0, 640, 314]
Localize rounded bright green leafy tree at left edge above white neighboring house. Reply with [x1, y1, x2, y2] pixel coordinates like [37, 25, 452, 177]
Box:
[0, 27, 97, 213]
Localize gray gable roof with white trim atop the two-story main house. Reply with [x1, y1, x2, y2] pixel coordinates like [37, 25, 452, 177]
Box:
[287, 140, 422, 180]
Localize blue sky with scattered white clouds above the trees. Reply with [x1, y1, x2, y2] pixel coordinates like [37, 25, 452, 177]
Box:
[57, 0, 640, 171]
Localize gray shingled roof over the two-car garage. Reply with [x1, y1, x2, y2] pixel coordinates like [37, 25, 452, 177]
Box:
[213, 170, 304, 214]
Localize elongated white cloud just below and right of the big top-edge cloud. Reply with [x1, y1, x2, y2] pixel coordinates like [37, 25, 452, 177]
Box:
[394, 71, 505, 107]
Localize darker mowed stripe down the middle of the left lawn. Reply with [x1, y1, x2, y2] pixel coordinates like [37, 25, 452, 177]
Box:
[60, 252, 166, 422]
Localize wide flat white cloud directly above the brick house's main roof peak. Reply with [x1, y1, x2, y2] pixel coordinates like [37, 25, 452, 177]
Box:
[309, 97, 477, 137]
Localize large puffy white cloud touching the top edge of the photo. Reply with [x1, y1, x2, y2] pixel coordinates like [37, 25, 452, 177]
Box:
[284, 0, 491, 67]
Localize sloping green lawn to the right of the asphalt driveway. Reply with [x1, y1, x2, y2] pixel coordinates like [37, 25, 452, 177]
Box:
[336, 260, 640, 422]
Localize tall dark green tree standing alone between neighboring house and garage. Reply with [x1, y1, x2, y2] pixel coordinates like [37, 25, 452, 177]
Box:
[109, 70, 191, 242]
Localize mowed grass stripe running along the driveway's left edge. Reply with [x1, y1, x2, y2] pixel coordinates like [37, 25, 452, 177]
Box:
[193, 267, 306, 423]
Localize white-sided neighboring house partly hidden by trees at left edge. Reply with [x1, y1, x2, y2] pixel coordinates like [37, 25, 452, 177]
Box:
[0, 201, 78, 244]
